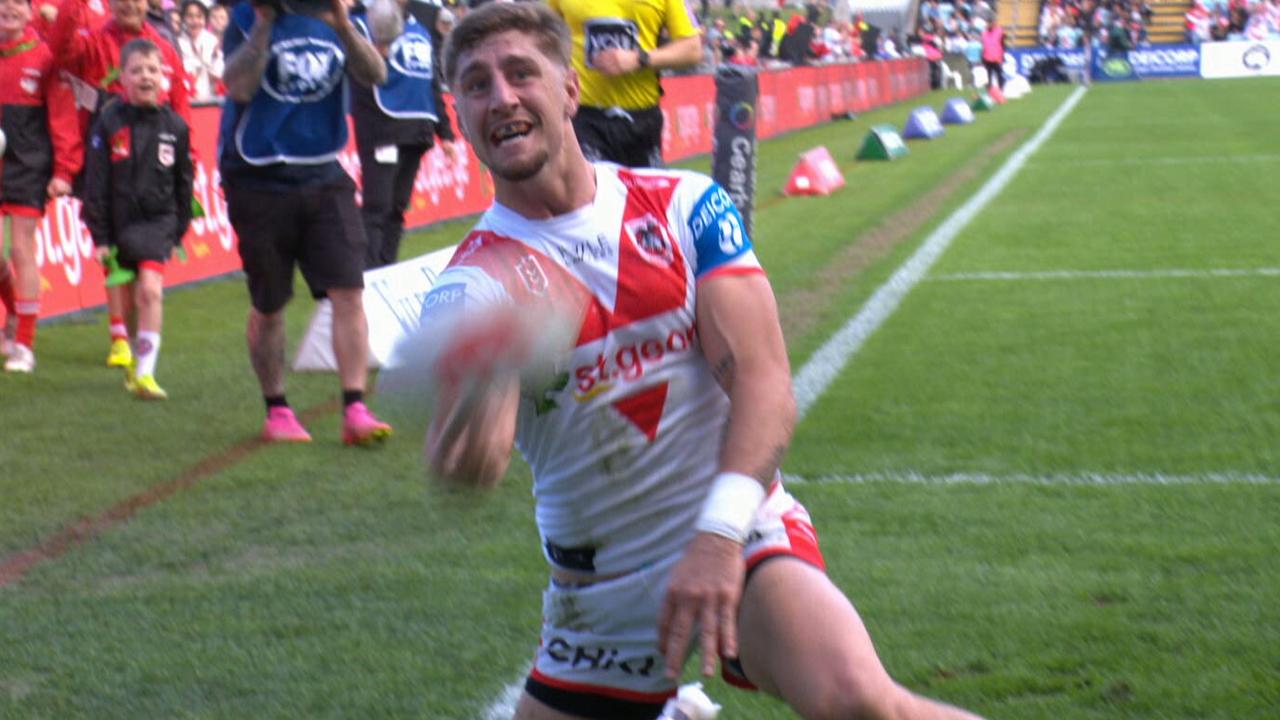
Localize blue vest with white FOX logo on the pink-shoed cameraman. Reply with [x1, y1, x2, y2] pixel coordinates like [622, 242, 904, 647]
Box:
[219, 3, 347, 165]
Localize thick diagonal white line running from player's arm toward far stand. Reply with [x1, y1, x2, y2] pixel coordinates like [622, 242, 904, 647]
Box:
[794, 87, 1084, 419]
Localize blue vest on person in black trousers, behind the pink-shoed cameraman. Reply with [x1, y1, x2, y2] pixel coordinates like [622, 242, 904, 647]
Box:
[352, 14, 438, 122]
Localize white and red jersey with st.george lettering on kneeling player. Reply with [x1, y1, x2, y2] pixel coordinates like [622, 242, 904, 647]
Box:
[424, 163, 763, 574]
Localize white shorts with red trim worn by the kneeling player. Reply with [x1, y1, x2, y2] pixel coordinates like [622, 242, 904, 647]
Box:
[525, 483, 826, 720]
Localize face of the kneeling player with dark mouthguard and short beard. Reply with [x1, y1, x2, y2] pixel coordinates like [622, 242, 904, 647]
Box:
[454, 31, 577, 182]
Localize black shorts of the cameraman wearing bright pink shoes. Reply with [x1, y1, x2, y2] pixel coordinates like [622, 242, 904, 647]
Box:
[224, 181, 366, 315]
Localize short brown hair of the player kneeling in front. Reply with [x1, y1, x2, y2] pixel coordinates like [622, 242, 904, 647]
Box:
[444, 3, 571, 85]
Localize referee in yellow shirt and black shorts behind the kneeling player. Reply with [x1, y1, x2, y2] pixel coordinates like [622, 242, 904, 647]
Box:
[549, 0, 703, 168]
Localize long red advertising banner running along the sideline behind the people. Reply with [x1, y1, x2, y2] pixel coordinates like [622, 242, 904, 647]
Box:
[36, 58, 928, 318]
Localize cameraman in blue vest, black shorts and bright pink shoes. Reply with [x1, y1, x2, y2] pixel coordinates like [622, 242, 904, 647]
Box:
[219, 0, 390, 445]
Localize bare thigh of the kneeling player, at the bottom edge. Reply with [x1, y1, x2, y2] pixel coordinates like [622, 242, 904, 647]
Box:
[739, 557, 895, 715]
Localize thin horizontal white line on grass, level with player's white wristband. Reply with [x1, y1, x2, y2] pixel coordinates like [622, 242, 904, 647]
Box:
[782, 470, 1280, 486]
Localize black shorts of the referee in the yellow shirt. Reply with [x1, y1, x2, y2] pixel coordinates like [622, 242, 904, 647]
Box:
[573, 105, 662, 168]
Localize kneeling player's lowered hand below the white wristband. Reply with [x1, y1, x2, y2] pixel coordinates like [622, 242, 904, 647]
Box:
[658, 533, 746, 679]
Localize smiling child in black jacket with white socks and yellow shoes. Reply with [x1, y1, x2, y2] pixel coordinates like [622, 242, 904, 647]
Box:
[82, 38, 193, 400]
